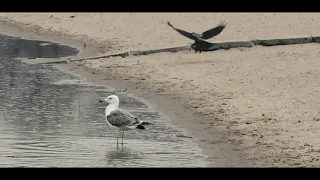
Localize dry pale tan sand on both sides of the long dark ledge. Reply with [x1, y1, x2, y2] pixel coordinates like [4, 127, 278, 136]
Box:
[0, 13, 320, 167]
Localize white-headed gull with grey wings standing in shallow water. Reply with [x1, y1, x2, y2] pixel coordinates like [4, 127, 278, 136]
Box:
[99, 95, 151, 145]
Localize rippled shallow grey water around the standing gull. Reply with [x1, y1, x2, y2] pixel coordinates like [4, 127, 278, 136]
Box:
[0, 35, 207, 167]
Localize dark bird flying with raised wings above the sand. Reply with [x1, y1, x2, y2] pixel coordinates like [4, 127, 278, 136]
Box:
[167, 21, 227, 53]
